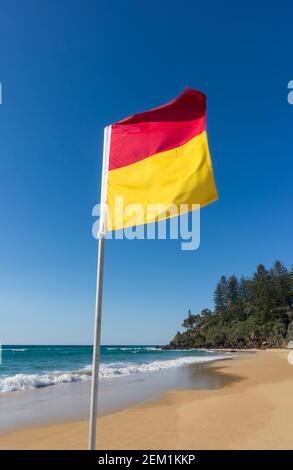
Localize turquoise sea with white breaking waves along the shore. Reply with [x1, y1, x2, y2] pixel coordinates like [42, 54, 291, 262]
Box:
[0, 345, 226, 393]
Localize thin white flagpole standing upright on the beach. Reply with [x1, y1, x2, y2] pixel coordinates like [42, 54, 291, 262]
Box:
[89, 126, 111, 450]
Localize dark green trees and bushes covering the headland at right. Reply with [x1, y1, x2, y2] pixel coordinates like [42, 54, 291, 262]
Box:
[167, 261, 293, 349]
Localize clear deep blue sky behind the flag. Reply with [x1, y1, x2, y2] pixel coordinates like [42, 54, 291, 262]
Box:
[0, 0, 293, 344]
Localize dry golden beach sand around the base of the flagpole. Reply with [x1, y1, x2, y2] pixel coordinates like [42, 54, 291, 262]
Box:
[0, 350, 293, 450]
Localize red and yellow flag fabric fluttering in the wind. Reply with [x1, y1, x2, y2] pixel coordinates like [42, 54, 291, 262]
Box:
[106, 89, 218, 230]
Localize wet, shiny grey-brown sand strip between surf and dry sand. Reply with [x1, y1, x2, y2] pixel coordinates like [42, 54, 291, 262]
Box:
[0, 354, 233, 436]
